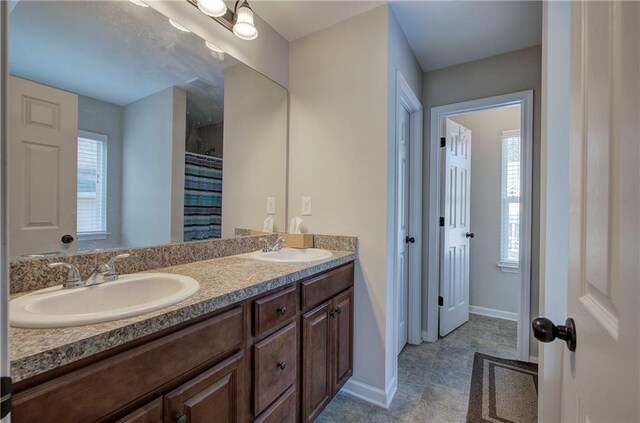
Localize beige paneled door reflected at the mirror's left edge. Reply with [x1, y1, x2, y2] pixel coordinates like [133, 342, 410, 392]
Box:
[7, 77, 78, 258]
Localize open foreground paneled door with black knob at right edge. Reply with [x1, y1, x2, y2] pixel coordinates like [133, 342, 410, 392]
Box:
[560, 2, 640, 422]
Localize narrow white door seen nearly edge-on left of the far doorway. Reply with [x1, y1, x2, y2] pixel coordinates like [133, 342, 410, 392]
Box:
[396, 106, 410, 354]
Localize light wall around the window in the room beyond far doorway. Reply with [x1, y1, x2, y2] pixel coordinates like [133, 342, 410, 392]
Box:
[452, 106, 521, 313]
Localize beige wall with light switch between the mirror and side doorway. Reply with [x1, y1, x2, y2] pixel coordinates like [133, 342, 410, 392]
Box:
[289, 6, 421, 401]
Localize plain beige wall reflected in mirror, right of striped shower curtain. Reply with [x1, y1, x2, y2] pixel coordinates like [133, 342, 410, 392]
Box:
[222, 64, 287, 238]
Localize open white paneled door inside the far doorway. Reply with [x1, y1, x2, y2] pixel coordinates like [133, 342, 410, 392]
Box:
[440, 119, 471, 336]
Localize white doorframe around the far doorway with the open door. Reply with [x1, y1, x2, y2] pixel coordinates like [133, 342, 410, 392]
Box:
[424, 90, 533, 361]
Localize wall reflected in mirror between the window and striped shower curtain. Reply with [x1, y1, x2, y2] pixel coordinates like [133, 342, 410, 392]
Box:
[121, 87, 187, 247]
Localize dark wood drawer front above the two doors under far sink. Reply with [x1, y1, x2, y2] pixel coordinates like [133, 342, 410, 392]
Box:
[300, 263, 353, 311]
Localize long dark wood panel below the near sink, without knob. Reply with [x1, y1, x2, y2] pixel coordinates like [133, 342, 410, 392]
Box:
[12, 306, 244, 423]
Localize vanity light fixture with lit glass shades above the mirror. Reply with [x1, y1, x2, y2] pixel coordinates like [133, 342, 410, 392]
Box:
[186, 0, 258, 40]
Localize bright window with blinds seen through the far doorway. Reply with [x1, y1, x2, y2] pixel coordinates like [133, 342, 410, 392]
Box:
[500, 130, 521, 269]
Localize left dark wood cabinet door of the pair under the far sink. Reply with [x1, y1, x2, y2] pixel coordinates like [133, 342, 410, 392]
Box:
[302, 301, 333, 422]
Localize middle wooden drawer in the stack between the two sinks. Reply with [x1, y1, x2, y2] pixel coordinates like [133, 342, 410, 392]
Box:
[253, 322, 298, 415]
